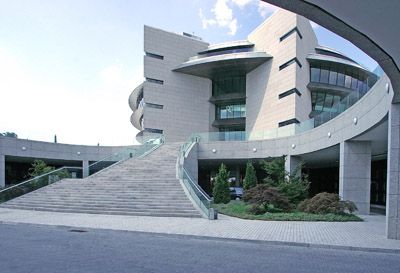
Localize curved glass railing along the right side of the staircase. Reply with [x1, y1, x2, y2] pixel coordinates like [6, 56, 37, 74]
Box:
[176, 141, 216, 220]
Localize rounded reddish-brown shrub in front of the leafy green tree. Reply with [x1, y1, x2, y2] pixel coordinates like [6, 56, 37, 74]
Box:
[243, 184, 290, 213]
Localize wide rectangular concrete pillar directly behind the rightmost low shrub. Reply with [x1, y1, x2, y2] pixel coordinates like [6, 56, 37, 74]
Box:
[339, 141, 371, 215]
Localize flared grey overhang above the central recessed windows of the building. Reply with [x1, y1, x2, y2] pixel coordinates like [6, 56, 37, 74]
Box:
[173, 52, 272, 79]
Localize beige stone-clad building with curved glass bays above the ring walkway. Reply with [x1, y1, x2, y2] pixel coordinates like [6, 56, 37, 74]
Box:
[129, 10, 377, 142]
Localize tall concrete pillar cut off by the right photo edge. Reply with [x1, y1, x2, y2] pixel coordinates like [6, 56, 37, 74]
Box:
[386, 104, 400, 240]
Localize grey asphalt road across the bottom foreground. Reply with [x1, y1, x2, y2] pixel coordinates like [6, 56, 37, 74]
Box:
[0, 224, 400, 273]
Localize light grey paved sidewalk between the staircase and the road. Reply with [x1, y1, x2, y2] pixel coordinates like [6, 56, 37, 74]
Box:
[0, 208, 400, 250]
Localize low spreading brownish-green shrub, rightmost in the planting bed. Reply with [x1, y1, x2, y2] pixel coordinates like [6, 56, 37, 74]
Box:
[297, 192, 357, 214]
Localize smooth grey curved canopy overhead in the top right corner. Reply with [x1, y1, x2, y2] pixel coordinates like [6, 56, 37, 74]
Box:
[262, 0, 400, 103]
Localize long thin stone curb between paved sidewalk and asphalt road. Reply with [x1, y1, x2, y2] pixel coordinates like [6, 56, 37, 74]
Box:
[0, 221, 400, 254]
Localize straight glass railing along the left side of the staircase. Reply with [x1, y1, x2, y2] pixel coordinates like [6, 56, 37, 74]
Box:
[0, 167, 82, 203]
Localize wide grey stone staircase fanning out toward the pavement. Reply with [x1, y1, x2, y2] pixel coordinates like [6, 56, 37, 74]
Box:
[0, 143, 201, 217]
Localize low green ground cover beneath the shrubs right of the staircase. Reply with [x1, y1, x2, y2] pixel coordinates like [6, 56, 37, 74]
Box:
[213, 201, 363, 222]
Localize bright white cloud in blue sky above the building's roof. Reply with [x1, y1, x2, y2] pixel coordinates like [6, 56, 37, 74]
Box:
[199, 0, 238, 36]
